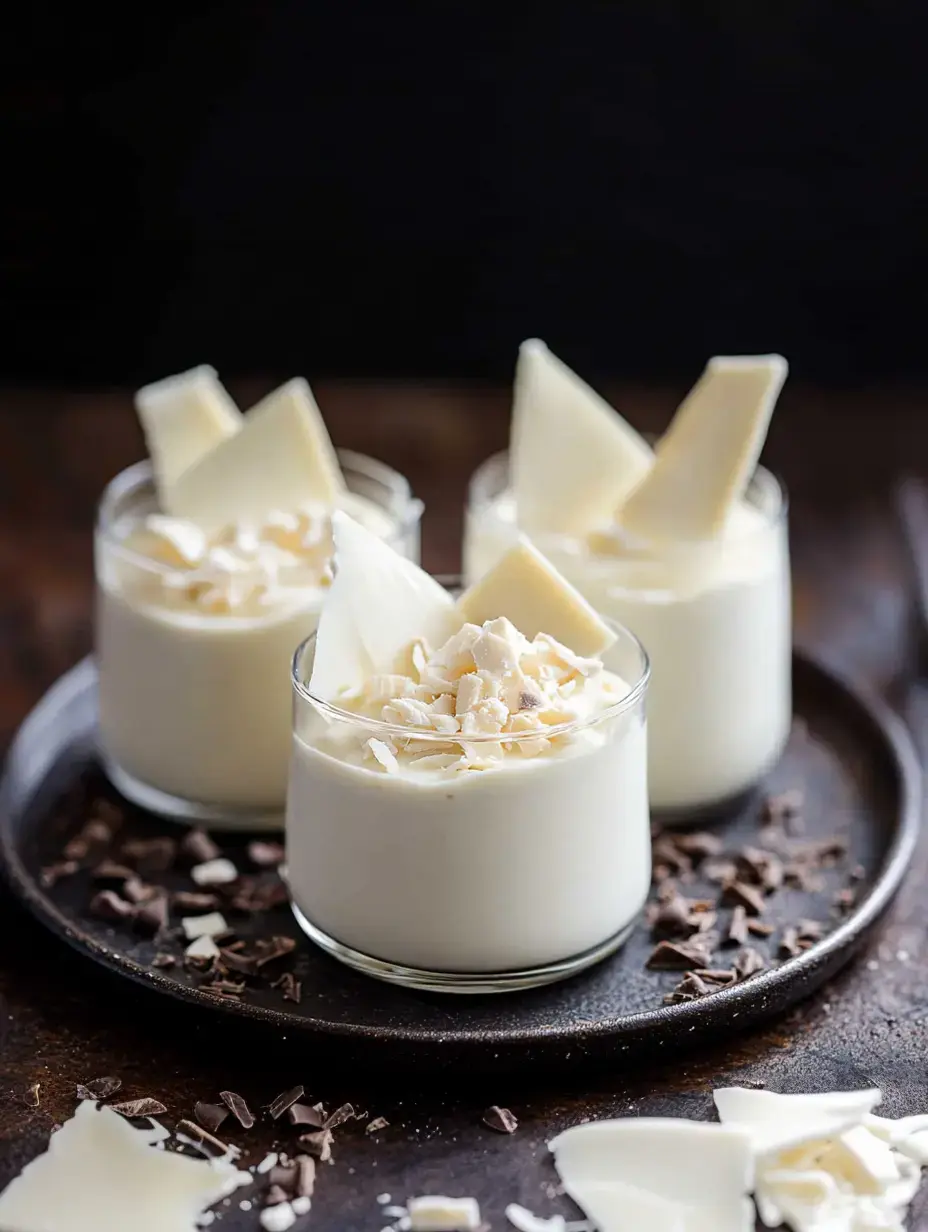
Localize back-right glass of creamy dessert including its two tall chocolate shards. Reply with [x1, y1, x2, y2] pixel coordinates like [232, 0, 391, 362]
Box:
[463, 342, 791, 813]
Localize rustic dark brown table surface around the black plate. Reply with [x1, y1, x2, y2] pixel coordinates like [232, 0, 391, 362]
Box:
[0, 382, 928, 1232]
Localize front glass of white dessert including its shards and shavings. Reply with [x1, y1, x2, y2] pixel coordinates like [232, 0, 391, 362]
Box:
[286, 514, 651, 992]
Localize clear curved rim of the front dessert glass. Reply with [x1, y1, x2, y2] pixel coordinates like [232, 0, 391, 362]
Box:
[290, 588, 651, 745]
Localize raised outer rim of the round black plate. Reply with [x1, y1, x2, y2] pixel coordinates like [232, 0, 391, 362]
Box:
[0, 646, 923, 1048]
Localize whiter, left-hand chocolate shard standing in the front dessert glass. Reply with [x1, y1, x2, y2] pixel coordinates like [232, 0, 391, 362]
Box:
[309, 510, 463, 701]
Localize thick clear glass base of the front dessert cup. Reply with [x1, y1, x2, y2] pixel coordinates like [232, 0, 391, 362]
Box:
[290, 901, 637, 993]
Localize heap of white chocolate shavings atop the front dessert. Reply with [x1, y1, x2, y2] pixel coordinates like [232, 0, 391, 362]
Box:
[325, 617, 629, 774]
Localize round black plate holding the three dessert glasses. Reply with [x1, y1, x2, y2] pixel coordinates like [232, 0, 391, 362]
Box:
[0, 653, 921, 1068]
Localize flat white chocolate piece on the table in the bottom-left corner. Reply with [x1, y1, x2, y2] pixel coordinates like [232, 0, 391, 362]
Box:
[0, 1100, 251, 1232]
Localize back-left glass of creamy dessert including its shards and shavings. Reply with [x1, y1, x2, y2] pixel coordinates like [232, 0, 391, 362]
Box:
[95, 367, 421, 827]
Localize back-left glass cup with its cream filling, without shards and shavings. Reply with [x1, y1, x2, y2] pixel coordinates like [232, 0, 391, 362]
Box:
[95, 450, 423, 829]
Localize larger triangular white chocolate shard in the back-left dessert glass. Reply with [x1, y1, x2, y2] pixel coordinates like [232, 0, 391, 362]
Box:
[169, 378, 344, 533]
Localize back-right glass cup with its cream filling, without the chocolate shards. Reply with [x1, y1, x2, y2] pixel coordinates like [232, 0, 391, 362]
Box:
[463, 453, 792, 822]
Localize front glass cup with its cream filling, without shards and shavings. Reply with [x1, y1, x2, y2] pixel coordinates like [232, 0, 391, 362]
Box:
[286, 601, 651, 993]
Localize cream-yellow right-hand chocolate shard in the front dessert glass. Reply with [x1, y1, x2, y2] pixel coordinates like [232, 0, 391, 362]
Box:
[457, 536, 616, 657]
